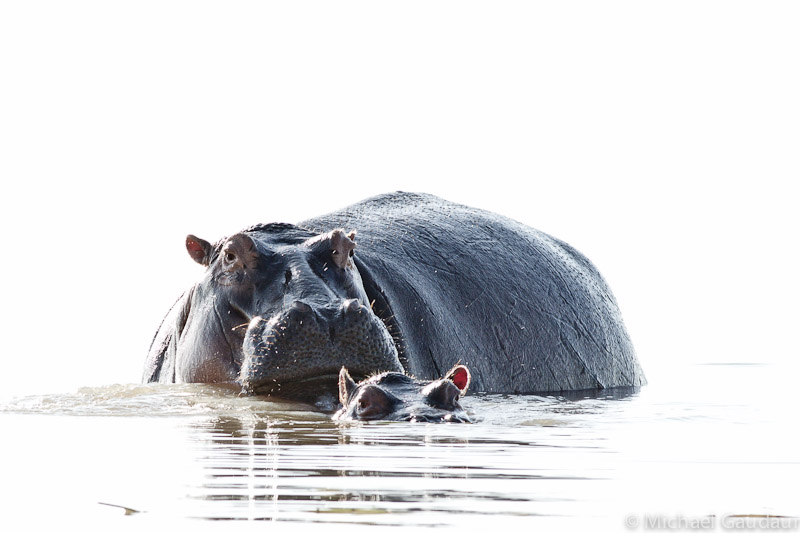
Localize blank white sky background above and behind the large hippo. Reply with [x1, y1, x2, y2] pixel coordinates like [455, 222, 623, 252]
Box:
[0, 0, 800, 396]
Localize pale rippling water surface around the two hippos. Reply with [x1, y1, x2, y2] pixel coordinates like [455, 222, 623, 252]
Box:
[0, 367, 800, 529]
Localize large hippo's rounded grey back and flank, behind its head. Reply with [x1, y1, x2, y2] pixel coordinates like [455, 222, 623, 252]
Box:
[300, 192, 645, 393]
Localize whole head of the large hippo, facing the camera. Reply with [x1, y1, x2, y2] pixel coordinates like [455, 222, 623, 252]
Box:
[175, 224, 402, 399]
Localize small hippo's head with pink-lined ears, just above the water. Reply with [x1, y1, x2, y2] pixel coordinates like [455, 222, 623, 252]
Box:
[333, 365, 471, 422]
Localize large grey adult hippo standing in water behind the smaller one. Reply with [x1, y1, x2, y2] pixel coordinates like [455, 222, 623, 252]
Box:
[144, 192, 645, 407]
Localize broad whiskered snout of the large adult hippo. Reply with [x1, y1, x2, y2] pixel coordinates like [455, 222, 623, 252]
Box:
[240, 298, 402, 396]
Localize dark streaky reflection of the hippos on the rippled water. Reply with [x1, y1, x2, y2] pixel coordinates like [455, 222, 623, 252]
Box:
[177, 391, 644, 525]
